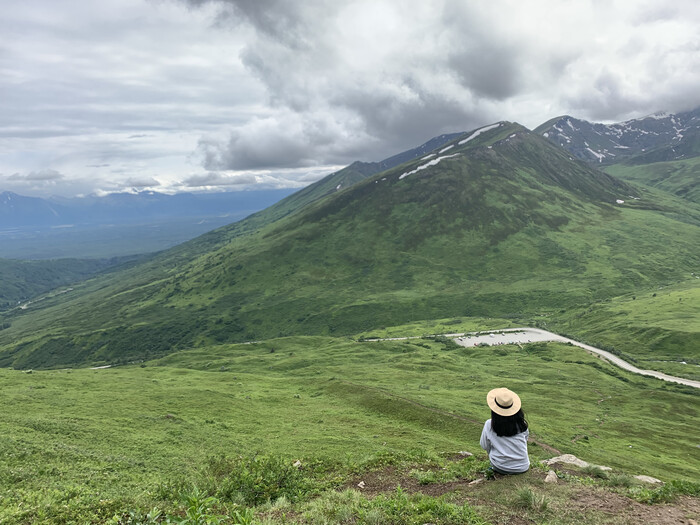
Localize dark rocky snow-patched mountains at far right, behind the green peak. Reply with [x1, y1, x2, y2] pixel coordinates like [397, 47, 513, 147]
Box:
[534, 108, 700, 164]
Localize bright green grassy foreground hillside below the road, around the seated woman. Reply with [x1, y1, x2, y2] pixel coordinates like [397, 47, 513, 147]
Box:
[0, 328, 700, 523]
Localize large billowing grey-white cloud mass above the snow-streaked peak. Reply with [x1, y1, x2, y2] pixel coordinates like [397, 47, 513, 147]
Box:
[179, 0, 700, 169]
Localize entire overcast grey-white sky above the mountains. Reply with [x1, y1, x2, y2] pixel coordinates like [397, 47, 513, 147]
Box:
[0, 0, 700, 196]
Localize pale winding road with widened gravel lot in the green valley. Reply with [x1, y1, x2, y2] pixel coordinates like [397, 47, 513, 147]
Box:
[366, 327, 700, 388]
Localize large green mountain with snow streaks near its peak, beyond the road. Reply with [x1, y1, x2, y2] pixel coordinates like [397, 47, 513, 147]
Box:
[0, 122, 700, 367]
